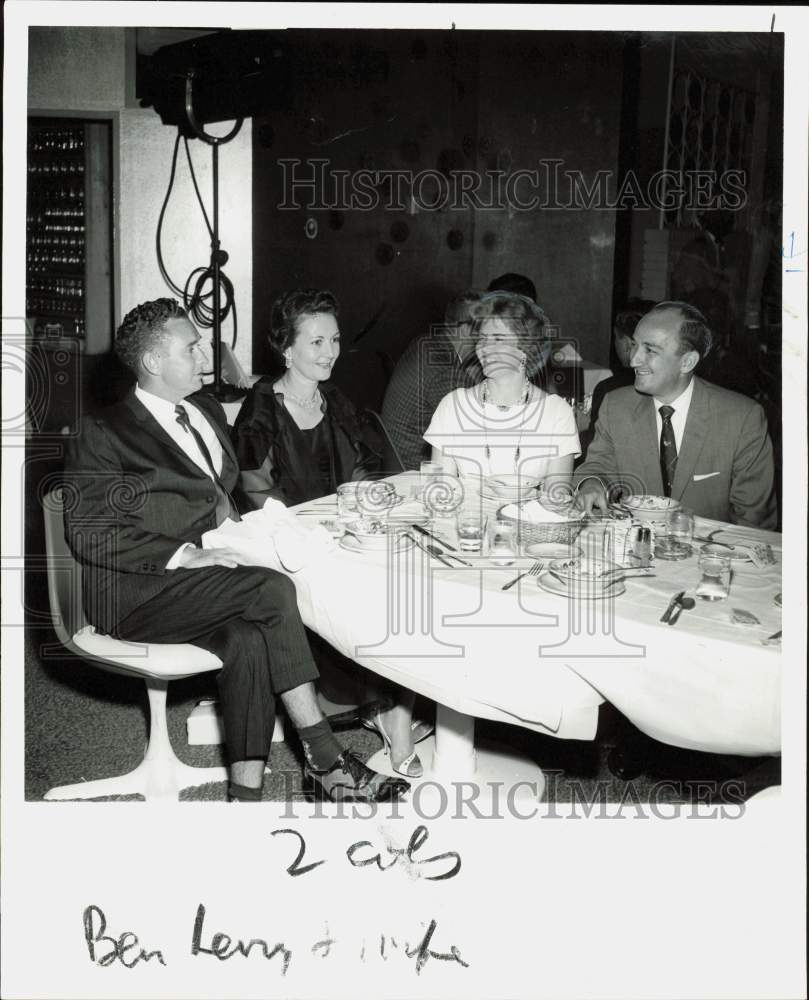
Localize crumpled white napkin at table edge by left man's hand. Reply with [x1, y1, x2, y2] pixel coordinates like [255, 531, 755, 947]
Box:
[207, 500, 336, 573]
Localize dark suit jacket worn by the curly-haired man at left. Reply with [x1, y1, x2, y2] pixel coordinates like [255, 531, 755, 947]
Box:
[65, 391, 239, 632]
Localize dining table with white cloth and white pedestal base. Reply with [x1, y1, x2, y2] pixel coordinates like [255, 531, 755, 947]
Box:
[203, 473, 781, 798]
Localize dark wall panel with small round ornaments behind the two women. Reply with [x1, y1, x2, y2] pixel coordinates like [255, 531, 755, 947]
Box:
[253, 31, 623, 405]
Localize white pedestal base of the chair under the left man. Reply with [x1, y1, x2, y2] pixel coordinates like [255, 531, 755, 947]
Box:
[45, 677, 228, 802]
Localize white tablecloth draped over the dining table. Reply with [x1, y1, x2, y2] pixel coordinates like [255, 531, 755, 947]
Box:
[206, 486, 781, 754]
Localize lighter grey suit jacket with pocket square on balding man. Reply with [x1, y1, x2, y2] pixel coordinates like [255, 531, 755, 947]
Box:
[575, 378, 777, 529]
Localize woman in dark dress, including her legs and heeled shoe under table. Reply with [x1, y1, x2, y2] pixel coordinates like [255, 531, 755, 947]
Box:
[233, 288, 431, 778]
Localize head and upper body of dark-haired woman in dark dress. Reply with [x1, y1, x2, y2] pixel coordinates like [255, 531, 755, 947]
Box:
[233, 288, 381, 507]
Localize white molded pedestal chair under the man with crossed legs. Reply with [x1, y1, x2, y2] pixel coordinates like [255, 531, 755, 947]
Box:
[42, 488, 228, 801]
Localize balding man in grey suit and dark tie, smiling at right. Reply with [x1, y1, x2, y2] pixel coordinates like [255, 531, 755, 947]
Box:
[575, 302, 777, 529]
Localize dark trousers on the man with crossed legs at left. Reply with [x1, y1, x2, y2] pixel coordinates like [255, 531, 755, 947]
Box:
[115, 566, 318, 762]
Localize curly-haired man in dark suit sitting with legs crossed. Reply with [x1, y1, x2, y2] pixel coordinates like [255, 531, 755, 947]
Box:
[65, 299, 407, 801]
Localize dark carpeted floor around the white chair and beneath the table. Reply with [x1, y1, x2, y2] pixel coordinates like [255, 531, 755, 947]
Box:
[25, 627, 780, 803]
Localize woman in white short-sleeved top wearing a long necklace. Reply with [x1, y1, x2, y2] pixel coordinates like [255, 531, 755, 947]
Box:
[424, 292, 580, 492]
